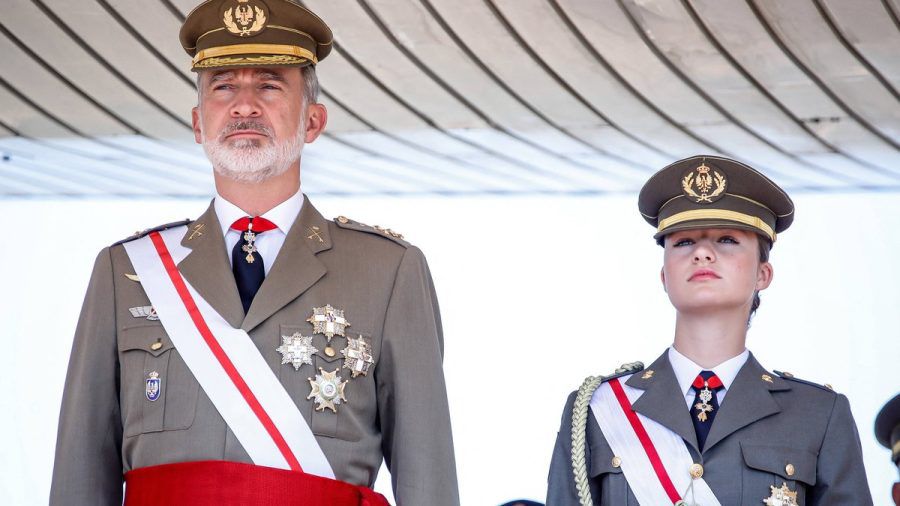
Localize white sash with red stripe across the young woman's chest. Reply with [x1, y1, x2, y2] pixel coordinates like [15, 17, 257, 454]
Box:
[591, 376, 721, 506]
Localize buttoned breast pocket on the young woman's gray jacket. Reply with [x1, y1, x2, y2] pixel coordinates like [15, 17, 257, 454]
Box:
[741, 442, 818, 505]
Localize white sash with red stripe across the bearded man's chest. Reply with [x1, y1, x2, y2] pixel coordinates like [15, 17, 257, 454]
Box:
[125, 226, 334, 478]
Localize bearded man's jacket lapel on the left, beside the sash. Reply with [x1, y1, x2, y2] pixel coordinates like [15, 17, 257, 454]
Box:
[178, 204, 244, 328]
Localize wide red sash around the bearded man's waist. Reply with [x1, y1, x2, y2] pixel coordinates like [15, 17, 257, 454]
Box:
[125, 461, 390, 506]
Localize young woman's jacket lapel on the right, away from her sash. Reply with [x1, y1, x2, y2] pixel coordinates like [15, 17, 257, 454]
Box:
[703, 353, 791, 453]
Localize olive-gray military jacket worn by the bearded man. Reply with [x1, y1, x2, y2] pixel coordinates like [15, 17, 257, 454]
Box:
[50, 198, 459, 506]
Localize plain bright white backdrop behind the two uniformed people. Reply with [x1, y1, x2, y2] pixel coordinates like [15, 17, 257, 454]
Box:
[0, 194, 900, 506]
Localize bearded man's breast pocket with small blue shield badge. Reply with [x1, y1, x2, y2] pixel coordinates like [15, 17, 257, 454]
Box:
[118, 325, 200, 437]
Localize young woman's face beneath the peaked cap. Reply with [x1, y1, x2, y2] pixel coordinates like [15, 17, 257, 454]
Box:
[661, 228, 772, 314]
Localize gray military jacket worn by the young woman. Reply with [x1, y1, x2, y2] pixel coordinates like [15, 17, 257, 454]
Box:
[547, 353, 872, 506]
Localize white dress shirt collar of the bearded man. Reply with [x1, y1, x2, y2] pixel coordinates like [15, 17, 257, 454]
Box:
[213, 190, 303, 275]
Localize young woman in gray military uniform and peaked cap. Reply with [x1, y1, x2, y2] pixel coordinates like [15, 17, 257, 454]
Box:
[547, 156, 872, 506]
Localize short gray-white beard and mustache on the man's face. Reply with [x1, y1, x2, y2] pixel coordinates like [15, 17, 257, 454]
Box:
[200, 120, 306, 183]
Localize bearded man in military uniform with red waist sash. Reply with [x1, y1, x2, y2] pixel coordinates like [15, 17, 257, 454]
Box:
[50, 0, 459, 506]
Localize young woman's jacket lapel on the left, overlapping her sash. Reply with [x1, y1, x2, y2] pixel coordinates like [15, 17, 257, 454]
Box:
[625, 350, 708, 453]
